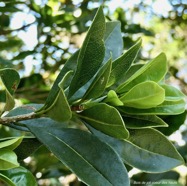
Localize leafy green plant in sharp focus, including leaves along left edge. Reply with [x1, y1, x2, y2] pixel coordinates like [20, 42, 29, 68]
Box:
[0, 8, 185, 186]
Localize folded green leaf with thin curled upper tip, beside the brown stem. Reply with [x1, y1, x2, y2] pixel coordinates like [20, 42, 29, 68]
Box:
[40, 71, 72, 122]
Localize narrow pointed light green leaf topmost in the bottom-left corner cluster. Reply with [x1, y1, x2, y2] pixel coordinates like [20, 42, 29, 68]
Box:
[0, 137, 23, 150]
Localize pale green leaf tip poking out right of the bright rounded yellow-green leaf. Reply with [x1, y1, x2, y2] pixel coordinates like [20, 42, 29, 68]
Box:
[160, 84, 185, 101]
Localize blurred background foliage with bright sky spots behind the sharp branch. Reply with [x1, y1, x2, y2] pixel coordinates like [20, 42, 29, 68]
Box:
[0, 0, 187, 186]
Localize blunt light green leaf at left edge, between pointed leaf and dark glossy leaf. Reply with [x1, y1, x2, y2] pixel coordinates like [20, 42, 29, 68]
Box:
[0, 149, 19, 170]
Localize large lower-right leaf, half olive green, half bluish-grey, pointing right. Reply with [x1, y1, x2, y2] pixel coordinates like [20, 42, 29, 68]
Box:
[87, 125, 184, 173]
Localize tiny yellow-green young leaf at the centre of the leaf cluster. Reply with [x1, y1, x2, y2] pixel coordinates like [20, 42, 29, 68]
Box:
[104, 90, 124, 106]
